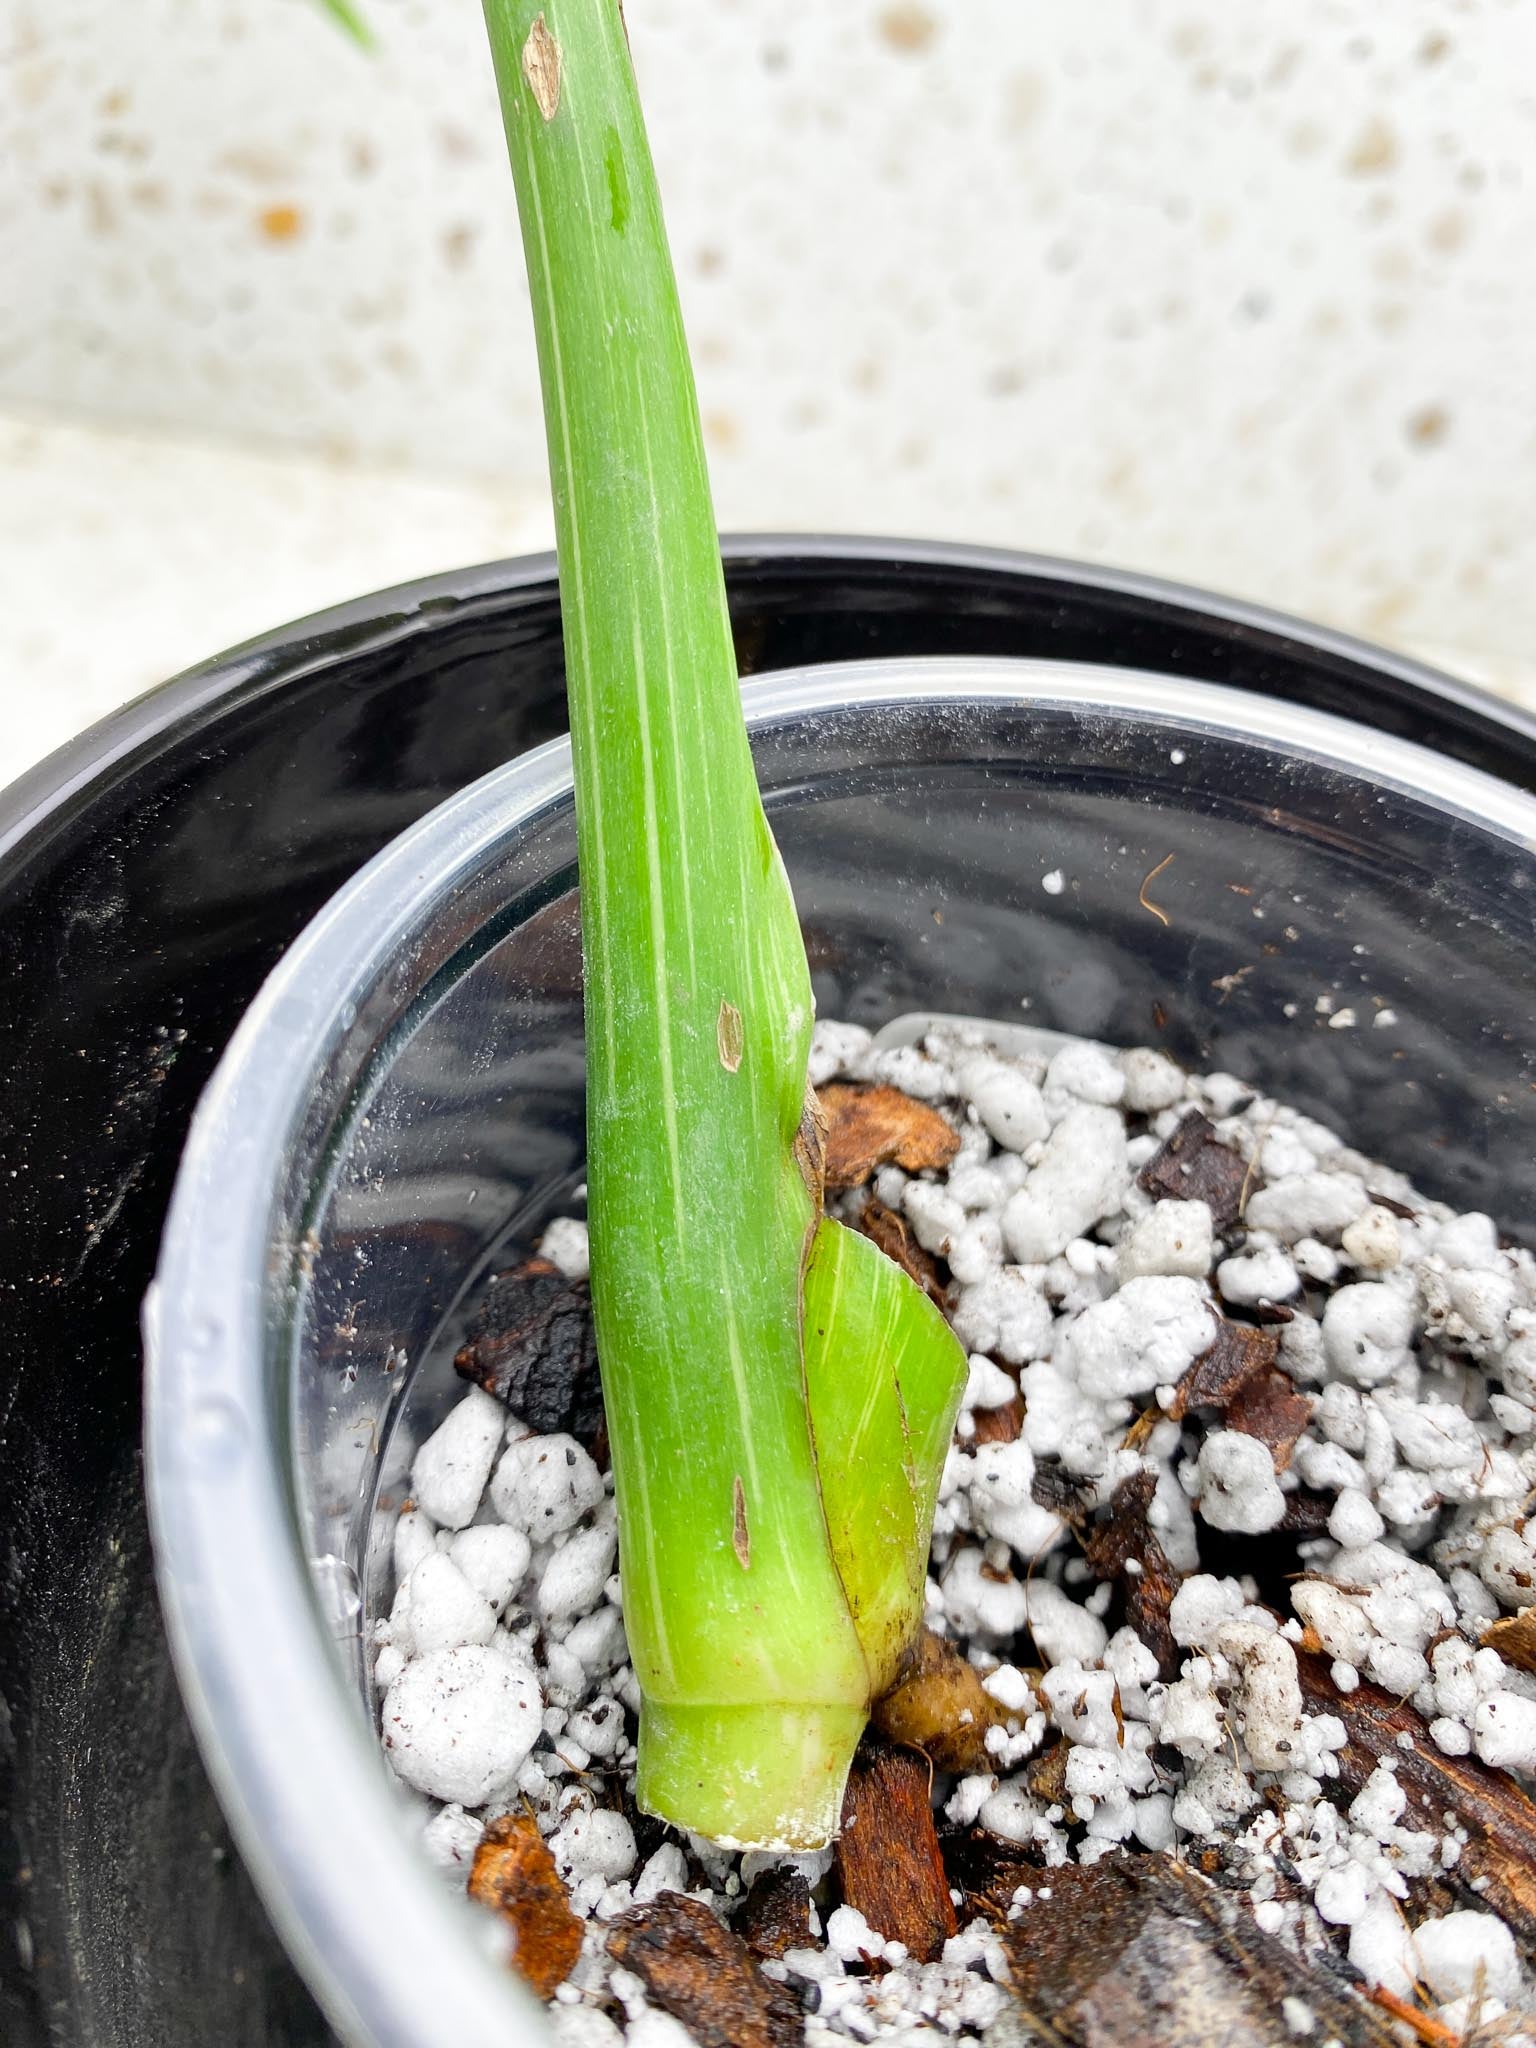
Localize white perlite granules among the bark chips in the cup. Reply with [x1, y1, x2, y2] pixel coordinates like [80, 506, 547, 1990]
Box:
[373, 1015, 1536, 2048]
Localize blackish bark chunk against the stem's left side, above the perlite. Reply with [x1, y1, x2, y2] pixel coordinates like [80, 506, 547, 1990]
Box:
[453, 1260, 602, 1442]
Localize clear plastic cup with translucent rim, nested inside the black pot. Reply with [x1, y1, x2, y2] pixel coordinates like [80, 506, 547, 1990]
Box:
[145, 659, 1536, 2048]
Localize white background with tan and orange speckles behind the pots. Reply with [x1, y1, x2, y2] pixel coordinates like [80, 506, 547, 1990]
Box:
[0, 0, 1536, 778]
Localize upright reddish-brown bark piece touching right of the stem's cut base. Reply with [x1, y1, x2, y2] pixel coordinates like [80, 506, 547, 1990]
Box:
[836, 1741, 956, 1962]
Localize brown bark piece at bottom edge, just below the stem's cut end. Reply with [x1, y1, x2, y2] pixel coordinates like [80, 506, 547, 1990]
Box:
[608, 1892, 805, 2048]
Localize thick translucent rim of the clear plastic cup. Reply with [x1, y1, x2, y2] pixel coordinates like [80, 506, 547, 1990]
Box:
[143, 657, 1536, 2048]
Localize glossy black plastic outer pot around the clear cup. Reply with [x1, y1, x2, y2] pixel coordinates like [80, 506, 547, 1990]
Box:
[0, 541, 1536, 2048]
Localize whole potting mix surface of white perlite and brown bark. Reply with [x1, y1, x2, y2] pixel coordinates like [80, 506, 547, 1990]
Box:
[375, 1024, 1536, 2048]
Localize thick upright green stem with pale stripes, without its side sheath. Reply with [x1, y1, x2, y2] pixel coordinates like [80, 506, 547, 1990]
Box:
[485, 0, 963, 1847]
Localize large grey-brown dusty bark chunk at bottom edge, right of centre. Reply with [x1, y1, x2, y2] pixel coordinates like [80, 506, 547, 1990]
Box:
[1004, 1855, 1397, 2048]
